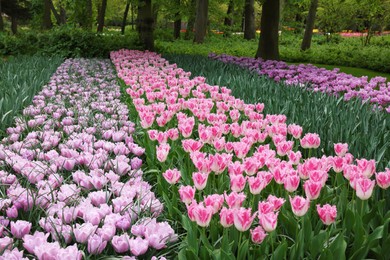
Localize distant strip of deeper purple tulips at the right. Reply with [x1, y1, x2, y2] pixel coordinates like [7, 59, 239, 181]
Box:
[209, 53, 390, 113]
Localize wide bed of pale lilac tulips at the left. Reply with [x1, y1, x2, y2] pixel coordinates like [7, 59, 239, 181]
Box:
[0, 59, 176, 259]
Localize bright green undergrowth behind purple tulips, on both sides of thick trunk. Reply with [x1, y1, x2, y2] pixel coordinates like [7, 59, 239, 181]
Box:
[156, 32, 390, 73]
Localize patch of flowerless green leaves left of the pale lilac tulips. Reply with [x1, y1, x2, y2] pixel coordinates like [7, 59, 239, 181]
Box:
[0, 56, 63, 136]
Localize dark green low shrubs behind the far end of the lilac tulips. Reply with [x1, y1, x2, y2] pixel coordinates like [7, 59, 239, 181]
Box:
[0, 27, 140, 58]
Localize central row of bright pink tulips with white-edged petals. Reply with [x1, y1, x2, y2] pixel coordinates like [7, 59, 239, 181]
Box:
[111, 50, 390, 259]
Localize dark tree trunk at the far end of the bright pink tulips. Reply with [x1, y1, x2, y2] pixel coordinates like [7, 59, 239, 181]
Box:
[137, 0, 154, 51]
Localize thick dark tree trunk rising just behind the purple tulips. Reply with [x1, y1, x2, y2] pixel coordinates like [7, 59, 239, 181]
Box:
[255, 0, 280, 60]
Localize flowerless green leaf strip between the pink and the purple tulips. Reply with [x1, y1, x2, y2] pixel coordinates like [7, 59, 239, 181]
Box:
[165, 55, 390, 170]
